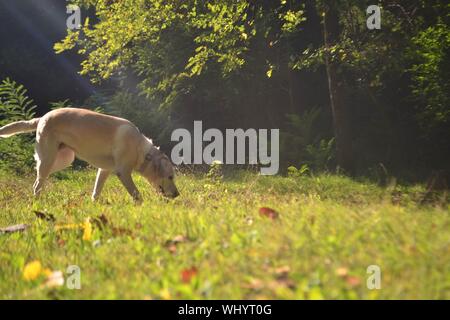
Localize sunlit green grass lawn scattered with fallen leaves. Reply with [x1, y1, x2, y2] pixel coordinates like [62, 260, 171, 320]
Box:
[0, 171, 450, 299]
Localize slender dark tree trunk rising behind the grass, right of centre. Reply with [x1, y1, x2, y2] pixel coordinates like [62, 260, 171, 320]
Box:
[323, 4, 355, 174]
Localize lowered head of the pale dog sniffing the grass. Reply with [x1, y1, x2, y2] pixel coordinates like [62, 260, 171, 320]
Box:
[140, 148, 179, 198]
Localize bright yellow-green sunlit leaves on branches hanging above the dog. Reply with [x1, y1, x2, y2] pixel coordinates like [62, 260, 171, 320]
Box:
[55, 0, 305, 105]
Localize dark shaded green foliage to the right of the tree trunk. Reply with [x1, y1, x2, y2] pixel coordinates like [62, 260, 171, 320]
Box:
[291, 0, 450, 172]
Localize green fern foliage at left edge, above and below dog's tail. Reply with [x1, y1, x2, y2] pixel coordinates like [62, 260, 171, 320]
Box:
[0, 78, 36, 173]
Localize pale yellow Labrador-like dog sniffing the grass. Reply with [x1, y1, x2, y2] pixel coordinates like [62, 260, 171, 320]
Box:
[0, 108, 179, 203]
